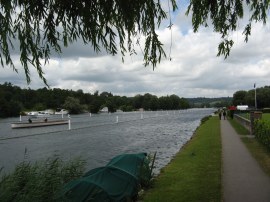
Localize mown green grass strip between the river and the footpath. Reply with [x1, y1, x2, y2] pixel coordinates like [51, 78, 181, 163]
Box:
[142, 117, 222, 202]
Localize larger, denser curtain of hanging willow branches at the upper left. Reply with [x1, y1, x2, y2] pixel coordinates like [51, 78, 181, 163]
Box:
[0, 0, 177, 83]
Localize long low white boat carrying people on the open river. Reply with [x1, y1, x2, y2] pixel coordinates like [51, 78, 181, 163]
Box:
[11, 119, 68, 129]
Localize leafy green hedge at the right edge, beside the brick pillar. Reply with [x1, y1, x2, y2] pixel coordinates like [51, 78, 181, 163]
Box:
[253, 119, 270, 150]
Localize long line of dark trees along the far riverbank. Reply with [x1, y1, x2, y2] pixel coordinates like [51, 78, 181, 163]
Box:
[0, 82, 190, 117]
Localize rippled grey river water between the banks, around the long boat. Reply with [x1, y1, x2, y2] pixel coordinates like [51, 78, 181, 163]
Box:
[0, 109, 214, 174]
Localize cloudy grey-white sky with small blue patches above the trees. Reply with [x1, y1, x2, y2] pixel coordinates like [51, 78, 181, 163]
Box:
[0, 1, 270, 98]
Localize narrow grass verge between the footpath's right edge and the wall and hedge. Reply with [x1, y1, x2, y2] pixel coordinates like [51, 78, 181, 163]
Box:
[230, 120, 270, 176]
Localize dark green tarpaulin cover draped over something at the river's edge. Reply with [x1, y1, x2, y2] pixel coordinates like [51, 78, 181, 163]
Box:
[59, 153, 151, 202]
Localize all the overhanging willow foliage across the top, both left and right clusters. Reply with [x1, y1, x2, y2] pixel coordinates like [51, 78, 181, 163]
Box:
[0, 0, 270, 84]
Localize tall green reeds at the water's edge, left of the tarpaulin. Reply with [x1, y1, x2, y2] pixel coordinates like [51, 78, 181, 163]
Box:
[0, 157, 85, 202]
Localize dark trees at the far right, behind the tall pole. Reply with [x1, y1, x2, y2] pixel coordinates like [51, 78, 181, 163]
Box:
[232, 86, 270, 109]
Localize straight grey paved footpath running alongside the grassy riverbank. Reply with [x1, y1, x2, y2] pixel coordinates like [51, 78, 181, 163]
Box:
[221, 120, 270, 202]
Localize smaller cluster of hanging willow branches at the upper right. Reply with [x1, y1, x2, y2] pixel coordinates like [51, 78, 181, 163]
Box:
[186, 0, 270, 58]
